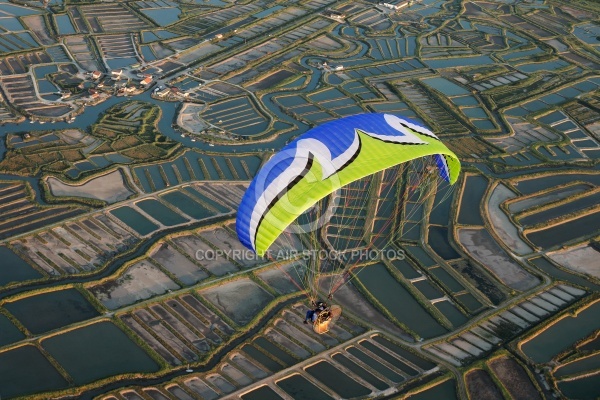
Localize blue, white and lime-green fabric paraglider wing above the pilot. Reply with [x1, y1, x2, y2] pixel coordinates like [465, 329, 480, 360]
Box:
[236, 114, 460, 255]
